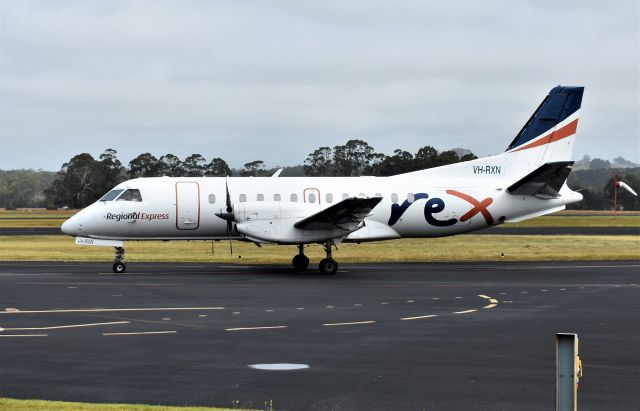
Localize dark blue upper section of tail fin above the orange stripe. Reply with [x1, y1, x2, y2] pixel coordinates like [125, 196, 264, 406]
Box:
[507, 86, 584, 151]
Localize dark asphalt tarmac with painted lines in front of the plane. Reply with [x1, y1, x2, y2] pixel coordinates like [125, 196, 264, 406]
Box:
[0, 261, 640, 410]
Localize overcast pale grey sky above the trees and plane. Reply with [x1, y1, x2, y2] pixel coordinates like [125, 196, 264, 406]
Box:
[0, 0, 640, 170]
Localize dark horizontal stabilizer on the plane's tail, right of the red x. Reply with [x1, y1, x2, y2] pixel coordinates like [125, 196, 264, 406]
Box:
[507, 161, 573, 198]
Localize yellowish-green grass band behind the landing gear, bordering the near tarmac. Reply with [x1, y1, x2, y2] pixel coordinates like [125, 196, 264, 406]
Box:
[0, 235, 640, 264]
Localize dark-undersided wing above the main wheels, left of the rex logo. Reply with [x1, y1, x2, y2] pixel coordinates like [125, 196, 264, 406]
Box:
[294, 197, 382, 231]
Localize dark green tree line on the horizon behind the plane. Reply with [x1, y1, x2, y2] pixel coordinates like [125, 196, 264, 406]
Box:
[0, 139, 640, 210]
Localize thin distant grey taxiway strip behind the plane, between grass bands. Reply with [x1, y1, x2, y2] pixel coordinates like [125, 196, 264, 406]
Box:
[0, 226, 640, 236]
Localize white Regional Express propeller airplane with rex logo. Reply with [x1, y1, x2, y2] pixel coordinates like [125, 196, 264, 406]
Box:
[61, 86, 584, 274]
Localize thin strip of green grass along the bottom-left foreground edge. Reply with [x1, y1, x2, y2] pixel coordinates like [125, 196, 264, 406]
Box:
[0, 398, 255, 411]
